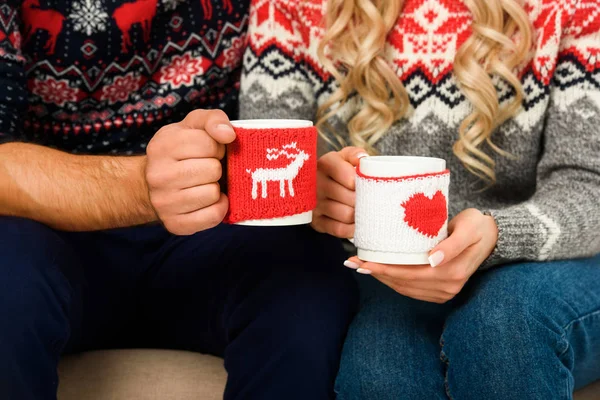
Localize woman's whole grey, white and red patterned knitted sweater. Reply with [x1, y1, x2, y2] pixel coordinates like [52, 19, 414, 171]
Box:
[240, 0, 600, 266]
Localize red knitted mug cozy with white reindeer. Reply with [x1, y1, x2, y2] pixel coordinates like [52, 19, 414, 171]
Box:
[225, 127, 317, 223]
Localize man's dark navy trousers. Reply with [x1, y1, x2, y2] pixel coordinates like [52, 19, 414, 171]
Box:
[0, 217, 357, 400]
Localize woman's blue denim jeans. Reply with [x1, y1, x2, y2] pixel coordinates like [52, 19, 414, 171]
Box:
[336, 256, 600, 400]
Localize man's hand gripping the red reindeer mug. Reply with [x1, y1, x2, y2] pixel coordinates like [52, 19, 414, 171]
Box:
[146, 110, 235, 235]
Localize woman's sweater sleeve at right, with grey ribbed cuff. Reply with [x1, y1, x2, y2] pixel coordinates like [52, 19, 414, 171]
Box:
[482, 0, 600, 268]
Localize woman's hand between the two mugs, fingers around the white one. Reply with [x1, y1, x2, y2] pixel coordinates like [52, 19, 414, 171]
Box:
[311, 147, 368, 239]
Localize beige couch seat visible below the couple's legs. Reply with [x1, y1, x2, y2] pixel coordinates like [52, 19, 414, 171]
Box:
[58, 350, 600, 400]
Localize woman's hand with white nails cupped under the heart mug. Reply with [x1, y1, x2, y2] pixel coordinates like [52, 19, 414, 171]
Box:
[344, 208, 498, 303]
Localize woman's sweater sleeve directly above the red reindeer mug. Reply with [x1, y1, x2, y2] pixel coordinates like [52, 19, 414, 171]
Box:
[240, 0, 318, 120]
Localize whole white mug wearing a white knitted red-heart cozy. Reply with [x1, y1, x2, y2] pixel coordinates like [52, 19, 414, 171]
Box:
[354, 156, 450, 264]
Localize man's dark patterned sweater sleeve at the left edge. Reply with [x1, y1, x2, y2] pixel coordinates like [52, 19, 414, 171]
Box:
[0, 1, 27, 144]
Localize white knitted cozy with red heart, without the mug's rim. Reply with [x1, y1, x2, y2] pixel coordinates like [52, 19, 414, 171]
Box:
[354, 167, 450, 253]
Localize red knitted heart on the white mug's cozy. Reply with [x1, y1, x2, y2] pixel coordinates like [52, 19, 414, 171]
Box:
[402, 190, 448, 238]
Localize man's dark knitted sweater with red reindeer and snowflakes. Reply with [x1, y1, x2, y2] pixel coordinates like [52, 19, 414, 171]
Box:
[0, 0, 249, 154]
